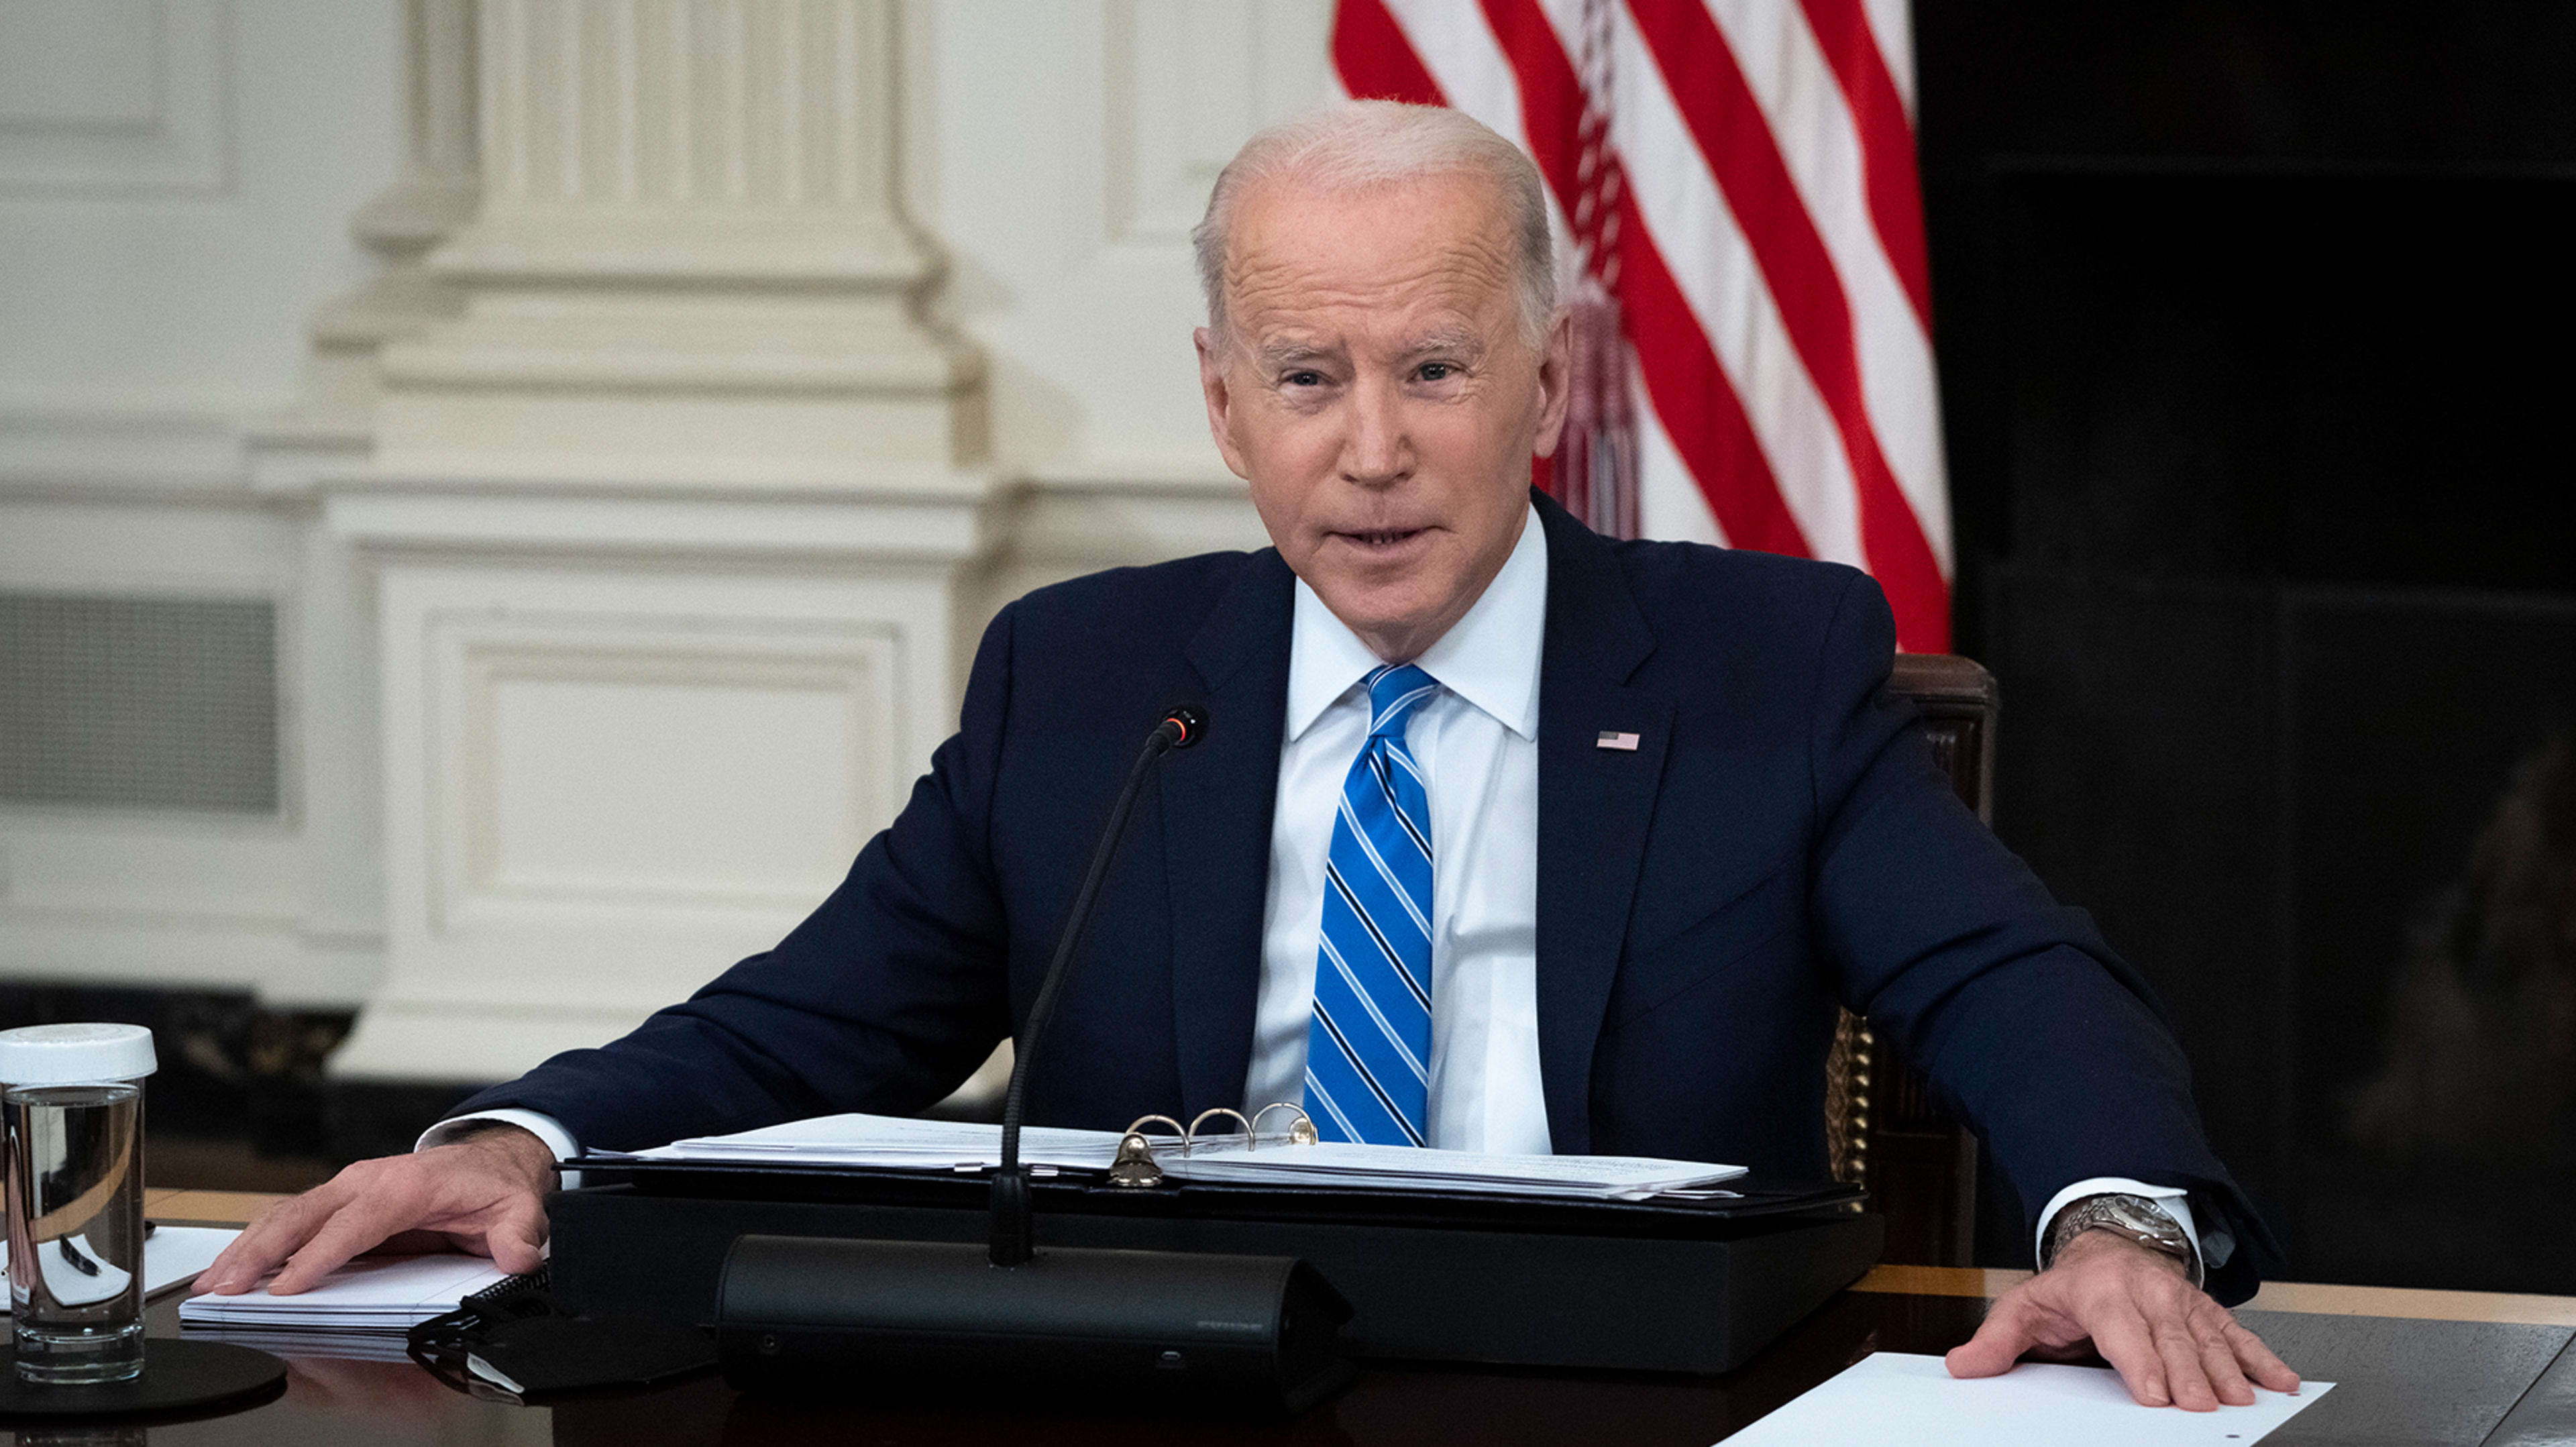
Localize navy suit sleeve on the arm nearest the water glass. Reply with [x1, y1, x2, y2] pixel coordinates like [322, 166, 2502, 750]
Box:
[456, 592, 1015, 1151]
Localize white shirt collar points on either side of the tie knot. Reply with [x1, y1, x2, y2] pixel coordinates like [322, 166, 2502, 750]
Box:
[1288, 507, 1548, 741]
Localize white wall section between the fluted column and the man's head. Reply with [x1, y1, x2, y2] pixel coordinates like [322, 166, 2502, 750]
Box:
[917, 0, 1332, 484]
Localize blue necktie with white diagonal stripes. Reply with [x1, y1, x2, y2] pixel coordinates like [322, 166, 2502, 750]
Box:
[1306, 664, 1440, 1146]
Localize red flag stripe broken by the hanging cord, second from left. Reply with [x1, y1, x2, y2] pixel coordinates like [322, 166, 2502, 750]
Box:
[1484, 0, 1813, 559]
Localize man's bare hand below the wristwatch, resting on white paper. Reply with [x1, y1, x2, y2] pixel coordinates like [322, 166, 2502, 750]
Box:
[1950, 1231, 2298, 1411]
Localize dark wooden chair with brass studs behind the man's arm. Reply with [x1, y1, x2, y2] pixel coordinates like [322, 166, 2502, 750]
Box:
[1824, 654, 1996, 1267]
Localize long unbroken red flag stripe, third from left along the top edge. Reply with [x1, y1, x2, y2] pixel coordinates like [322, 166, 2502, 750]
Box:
[1628, 0, 1950, 651]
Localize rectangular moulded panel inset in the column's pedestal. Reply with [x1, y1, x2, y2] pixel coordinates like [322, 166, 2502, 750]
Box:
[443, 612, 907, 916]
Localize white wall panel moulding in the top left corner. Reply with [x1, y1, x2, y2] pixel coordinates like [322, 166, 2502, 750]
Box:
[0, 0, 234, 196]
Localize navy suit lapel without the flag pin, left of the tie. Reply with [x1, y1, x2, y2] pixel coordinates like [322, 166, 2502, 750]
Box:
[1162, 551, 1296, 1120]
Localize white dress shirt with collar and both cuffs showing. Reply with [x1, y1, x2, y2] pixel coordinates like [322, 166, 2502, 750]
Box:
[420, 507, 2233, 1264]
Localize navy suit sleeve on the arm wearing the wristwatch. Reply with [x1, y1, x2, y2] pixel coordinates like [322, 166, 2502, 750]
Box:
[1811, 574, 2279, 1300]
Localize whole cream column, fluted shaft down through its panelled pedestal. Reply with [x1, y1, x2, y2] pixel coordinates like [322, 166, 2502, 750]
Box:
[325, 0, 994, 1081]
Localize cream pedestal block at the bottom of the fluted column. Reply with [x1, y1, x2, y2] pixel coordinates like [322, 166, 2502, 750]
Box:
[332, 553, 958, 1079]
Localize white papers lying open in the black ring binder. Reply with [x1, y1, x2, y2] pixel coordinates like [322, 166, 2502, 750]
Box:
[592, 1115, 1744, 1200]
